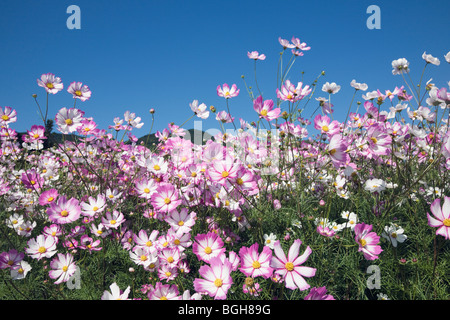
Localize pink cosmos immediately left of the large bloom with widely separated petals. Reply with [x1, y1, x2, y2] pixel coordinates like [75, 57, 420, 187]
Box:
[239, 243, 273, 279]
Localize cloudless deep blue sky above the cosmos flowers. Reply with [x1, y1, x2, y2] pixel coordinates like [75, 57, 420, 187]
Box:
[0, 0, 450, 137]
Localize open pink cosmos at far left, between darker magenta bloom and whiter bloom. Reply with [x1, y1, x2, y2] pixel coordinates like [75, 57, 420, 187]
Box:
[46, 196, 81, 224]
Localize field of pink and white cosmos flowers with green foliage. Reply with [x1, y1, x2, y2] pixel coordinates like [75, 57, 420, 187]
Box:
[0, 37, 450, 300]
